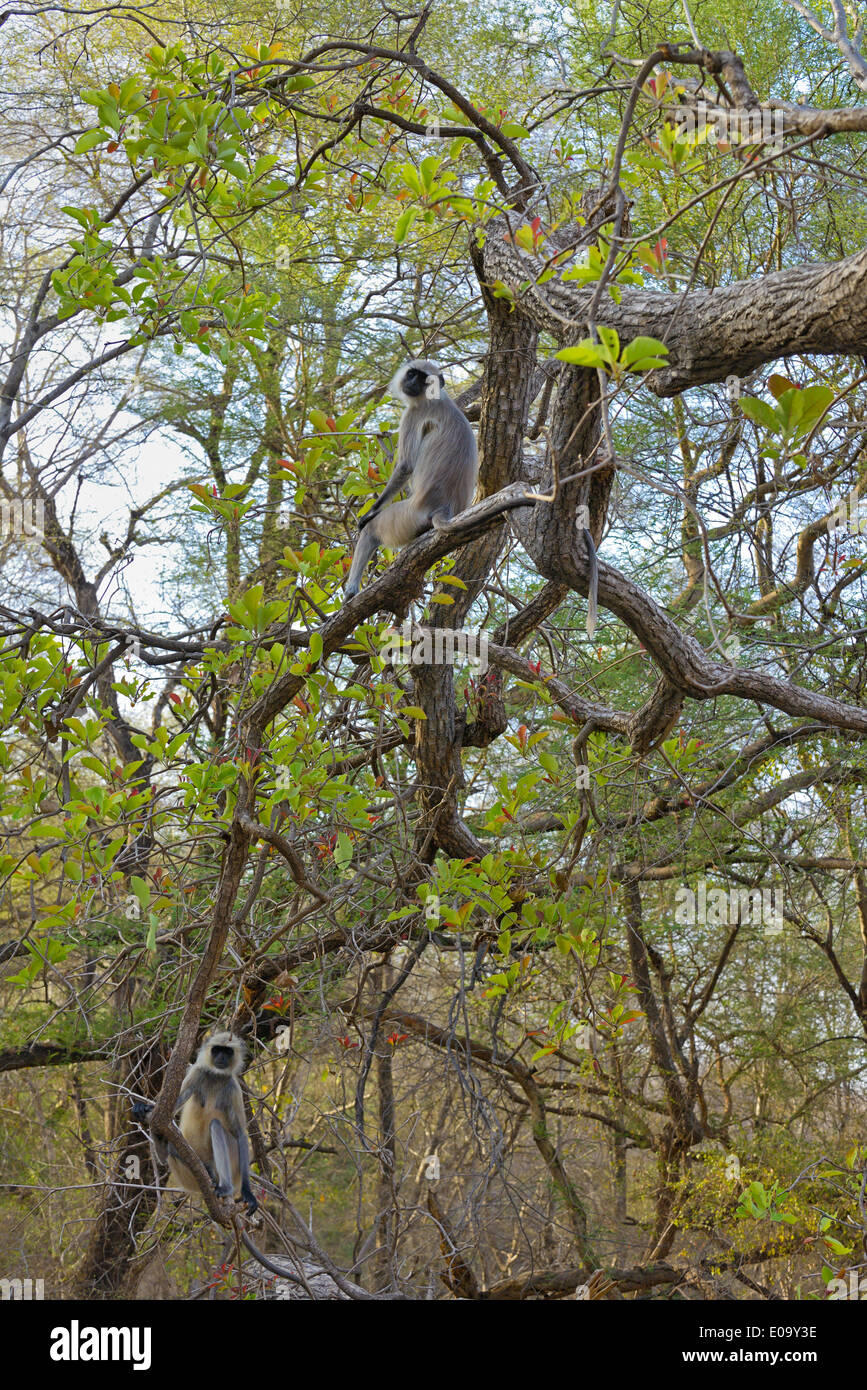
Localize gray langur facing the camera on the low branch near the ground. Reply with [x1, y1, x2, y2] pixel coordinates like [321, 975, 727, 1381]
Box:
[132, 1033, 258, 1212]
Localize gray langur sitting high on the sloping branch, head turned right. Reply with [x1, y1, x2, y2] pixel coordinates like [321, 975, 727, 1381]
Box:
[345, 361, 478, 599]
